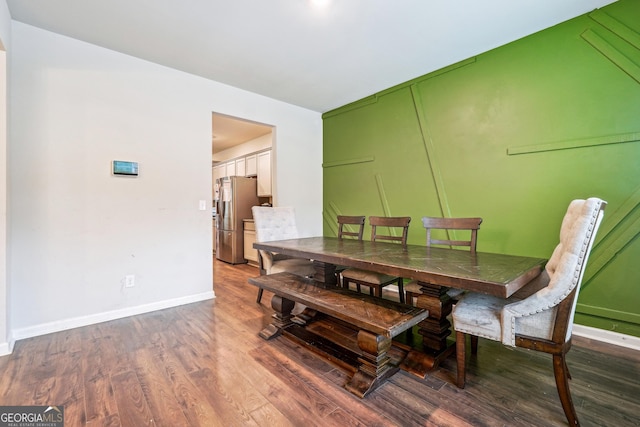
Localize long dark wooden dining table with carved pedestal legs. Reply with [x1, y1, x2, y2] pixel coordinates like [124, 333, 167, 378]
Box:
[253, 237, 546, 377]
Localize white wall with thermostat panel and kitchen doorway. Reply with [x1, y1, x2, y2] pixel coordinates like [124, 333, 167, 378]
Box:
[10, 22, 322, 338]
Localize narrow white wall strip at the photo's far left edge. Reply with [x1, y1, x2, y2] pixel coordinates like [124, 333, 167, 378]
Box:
[0, 0, 11, 356]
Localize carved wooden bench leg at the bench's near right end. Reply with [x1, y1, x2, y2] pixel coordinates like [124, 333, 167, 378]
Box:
[345, 330, 399, 398]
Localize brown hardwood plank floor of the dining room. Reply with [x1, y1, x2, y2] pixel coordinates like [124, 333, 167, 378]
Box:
[0, 262, 640, 427]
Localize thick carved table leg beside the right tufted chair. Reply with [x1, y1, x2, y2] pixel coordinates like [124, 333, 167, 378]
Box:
[401, 282, 455, 378]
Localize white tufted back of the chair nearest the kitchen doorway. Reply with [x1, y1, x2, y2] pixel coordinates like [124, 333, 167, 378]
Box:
[251, 206, 299, 242]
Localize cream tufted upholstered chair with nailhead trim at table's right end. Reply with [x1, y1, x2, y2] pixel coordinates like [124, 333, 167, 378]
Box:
[453, 198, 606, 426]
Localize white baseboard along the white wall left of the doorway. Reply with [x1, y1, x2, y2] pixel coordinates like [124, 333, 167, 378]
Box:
[11, 291, 216, 342]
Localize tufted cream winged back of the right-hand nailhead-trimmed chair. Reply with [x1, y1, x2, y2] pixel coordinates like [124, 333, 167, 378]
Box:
[502, 198, 607, 345]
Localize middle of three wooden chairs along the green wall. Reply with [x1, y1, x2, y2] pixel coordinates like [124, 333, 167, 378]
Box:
[342, 216, 411, 302]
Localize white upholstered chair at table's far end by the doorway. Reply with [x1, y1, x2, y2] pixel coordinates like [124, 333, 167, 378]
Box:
[251, 206, 315, 303]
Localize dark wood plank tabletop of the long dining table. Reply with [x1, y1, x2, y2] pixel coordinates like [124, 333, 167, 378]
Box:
[253, 237, 546, 298]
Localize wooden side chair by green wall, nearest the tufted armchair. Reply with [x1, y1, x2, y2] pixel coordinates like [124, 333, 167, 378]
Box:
[404, 216, 482, 304]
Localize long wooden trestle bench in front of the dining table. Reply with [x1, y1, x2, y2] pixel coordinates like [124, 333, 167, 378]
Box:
[249, 273, 429, 397]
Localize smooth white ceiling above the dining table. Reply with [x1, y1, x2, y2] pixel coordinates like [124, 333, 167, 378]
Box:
[7, 0, 613, 112]
